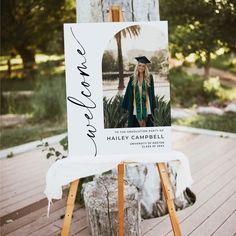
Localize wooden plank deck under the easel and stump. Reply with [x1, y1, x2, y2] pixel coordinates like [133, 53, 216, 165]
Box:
[0, 131, 236, 236]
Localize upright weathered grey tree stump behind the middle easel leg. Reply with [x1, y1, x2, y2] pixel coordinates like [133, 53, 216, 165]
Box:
[83, 175, 141, 236]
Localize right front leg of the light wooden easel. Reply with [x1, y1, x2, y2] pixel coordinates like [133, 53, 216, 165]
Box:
[157, 163, 181, 236]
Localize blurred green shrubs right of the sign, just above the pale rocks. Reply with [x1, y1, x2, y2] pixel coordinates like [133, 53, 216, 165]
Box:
[170, 67, 236, 107]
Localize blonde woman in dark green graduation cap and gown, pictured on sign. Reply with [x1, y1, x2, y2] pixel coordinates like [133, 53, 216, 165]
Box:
[122, 56, 156, 127]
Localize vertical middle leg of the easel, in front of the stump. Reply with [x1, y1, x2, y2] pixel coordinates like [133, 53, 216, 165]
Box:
[118, 163, 124, 236]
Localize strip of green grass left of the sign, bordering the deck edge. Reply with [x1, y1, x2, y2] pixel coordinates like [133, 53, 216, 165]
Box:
[0, 122, 67, 149]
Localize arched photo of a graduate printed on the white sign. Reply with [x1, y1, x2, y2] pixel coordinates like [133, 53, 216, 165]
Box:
[102, 24, 171, 128]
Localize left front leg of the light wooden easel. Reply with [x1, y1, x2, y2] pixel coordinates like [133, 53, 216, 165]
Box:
[61, 179, 79, 236]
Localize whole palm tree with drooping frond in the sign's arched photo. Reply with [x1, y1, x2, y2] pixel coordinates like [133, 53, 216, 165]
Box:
[115, 25, 141, 90]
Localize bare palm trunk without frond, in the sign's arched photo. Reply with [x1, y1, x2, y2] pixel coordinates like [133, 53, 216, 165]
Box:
[116, 32, 125, 90]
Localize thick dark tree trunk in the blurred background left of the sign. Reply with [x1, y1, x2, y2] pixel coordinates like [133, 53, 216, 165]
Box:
[17, 48, 36, 73]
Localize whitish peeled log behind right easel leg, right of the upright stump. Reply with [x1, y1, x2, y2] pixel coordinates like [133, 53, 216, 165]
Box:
[122, 161, 196, 219]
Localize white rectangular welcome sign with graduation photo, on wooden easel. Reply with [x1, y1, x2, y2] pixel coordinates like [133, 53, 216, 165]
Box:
[64, 22, 171, 158]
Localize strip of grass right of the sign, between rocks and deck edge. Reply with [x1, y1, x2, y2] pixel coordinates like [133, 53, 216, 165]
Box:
[172, 113, 236, 133]
